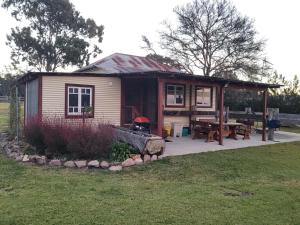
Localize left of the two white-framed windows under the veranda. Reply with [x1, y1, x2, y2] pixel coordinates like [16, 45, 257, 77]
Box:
[166, 84, 185, 107]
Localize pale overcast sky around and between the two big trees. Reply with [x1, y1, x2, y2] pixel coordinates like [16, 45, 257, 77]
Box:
[0, 0, 300, 79]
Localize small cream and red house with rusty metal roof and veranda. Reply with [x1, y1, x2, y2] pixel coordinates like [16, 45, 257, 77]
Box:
[19, 53, 280, 144]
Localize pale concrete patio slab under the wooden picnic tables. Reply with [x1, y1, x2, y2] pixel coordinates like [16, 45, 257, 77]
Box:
[163, 131, 300, 157]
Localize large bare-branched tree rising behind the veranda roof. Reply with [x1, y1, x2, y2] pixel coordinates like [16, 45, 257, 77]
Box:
[156, 0, 265, 80]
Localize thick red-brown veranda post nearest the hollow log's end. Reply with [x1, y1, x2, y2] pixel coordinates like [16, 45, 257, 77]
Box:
[157, 78, 164, 137]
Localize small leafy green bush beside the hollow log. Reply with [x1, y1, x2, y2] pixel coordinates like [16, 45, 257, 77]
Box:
[111, 142, 138, 162]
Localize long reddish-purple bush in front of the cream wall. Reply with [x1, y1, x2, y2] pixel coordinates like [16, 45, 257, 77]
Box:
[25, 118, 114, 159]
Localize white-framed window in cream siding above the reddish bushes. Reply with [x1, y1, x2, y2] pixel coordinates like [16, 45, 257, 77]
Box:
[67, 85, 93, 116]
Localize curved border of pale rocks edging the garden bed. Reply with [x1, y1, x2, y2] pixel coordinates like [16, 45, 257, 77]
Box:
[0, 133, 163, 171]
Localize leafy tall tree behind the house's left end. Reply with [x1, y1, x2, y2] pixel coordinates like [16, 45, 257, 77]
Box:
[2, 0, 104, 71]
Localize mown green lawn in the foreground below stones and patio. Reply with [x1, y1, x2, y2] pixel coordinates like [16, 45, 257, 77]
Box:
[0, 142, 300, 225]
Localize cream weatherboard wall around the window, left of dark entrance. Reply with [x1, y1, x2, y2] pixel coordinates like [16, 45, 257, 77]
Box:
[42, 75, 121, 126]
